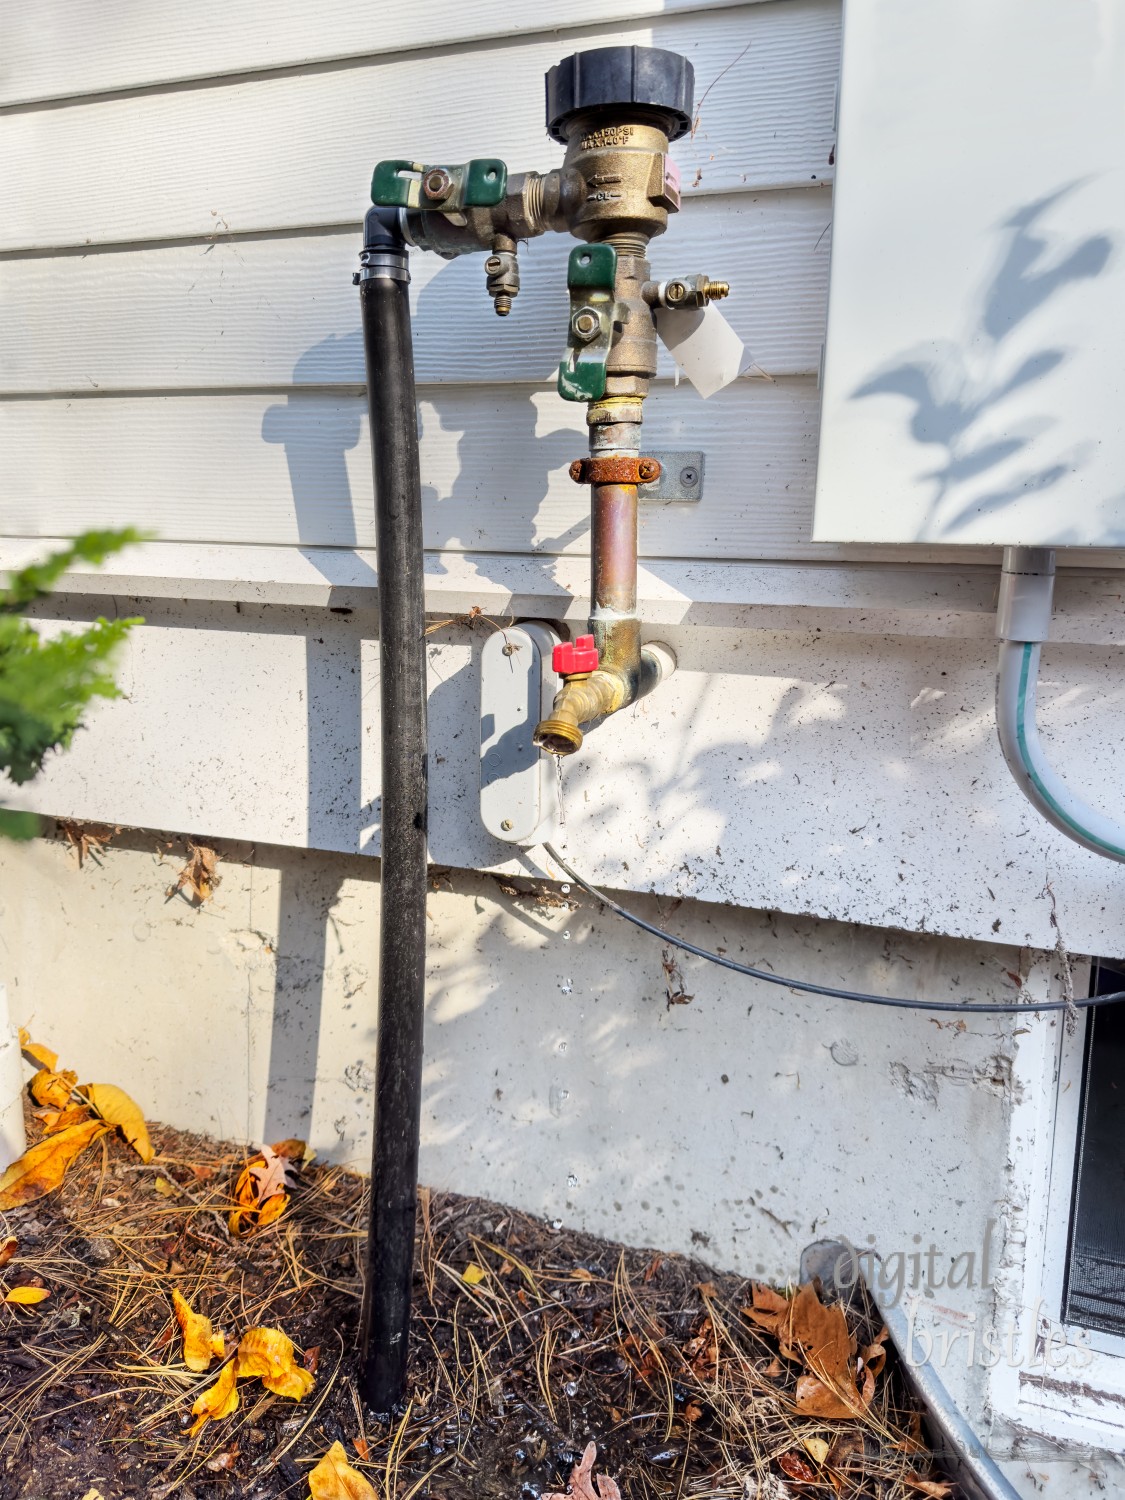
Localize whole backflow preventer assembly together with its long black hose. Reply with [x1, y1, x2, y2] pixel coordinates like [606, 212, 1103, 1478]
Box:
[356, 47, 728, 1412]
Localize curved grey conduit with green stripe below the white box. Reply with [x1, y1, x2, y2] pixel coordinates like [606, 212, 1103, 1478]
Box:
[996, 548, 1125, 861]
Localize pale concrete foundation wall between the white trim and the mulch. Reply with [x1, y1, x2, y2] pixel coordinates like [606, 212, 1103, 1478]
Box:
[0, 834, 1050, 1409]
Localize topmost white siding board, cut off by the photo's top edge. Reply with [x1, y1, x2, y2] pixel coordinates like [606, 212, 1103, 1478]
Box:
[0, 0, 792, 105]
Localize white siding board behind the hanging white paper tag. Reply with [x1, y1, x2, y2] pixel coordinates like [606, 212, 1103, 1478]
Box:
[0, 191, 831, 392]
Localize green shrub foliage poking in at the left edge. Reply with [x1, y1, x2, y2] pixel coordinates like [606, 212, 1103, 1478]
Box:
[0, 528, 143, 839]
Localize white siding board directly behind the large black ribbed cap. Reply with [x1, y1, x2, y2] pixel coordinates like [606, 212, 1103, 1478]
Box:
[0, 0, 839, 249]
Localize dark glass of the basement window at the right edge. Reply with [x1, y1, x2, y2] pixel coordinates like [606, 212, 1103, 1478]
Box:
[1062, 959, 1125, 1335]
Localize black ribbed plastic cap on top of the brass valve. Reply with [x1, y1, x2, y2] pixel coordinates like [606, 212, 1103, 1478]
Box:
[548, 47, 696, 141]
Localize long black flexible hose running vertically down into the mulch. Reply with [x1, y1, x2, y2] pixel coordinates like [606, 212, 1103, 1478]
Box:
[360, 212, 426, 1412]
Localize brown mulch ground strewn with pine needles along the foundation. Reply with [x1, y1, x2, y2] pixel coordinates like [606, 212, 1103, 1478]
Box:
[0, 1127, 947, 1500]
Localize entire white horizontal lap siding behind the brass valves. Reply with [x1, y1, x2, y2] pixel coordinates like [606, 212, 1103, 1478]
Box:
[0, 0, 846, 560]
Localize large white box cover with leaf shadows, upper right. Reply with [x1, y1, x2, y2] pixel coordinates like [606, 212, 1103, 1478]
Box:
[813, 0, 1125, 548]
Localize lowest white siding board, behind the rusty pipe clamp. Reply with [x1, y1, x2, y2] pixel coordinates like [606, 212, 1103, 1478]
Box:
[0, 380, 818, 558]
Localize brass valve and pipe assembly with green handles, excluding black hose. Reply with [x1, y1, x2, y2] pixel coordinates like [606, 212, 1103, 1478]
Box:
[371, 47, 729, 755]
